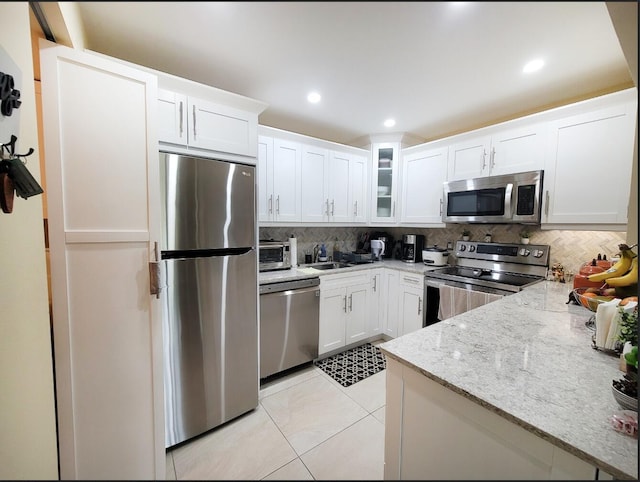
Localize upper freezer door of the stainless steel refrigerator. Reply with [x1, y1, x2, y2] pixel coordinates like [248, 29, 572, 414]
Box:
[160, 152, 256, 251]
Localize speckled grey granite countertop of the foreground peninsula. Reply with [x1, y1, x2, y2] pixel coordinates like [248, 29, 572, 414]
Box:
[379, 281, 638, 479]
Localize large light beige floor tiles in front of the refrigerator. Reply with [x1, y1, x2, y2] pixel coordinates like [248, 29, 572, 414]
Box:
[167, 348, 386, 480]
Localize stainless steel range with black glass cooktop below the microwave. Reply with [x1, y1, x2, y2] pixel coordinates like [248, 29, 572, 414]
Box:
[425, 241, 550, 326]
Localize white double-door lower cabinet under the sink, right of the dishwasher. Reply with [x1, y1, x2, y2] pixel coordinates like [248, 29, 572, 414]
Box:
[318, 270, 373, 355]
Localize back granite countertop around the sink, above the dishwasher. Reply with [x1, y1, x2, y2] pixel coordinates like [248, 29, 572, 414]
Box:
[258, 259, 441, 285]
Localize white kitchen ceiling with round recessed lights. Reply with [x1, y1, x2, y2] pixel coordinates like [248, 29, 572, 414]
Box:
[66, 2, 632, 144]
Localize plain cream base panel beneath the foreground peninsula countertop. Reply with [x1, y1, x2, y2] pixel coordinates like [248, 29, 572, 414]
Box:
[384, 358, 596, 480]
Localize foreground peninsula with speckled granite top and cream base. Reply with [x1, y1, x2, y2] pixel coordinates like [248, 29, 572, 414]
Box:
[379, 281, 638, 480]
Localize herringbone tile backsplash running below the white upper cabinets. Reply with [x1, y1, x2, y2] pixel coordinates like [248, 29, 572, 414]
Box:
[260, 224, 624, 273]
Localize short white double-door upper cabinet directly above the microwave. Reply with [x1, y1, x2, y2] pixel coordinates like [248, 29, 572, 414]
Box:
[448, 122, 546, 181]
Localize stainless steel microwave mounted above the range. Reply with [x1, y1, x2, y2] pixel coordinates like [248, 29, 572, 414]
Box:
[442, 170, 544, 224]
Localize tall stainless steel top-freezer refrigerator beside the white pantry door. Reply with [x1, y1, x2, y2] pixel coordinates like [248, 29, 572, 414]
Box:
[160, 152, 260, 447]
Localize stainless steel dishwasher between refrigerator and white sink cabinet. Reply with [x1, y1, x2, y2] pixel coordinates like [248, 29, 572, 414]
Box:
[260, 278, 320, 378]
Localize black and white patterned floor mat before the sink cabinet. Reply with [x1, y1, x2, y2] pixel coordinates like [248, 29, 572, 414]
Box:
[313, 343, 387, 387]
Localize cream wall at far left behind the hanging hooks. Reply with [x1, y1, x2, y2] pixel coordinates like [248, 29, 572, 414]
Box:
[0, 2, 58, 480]
